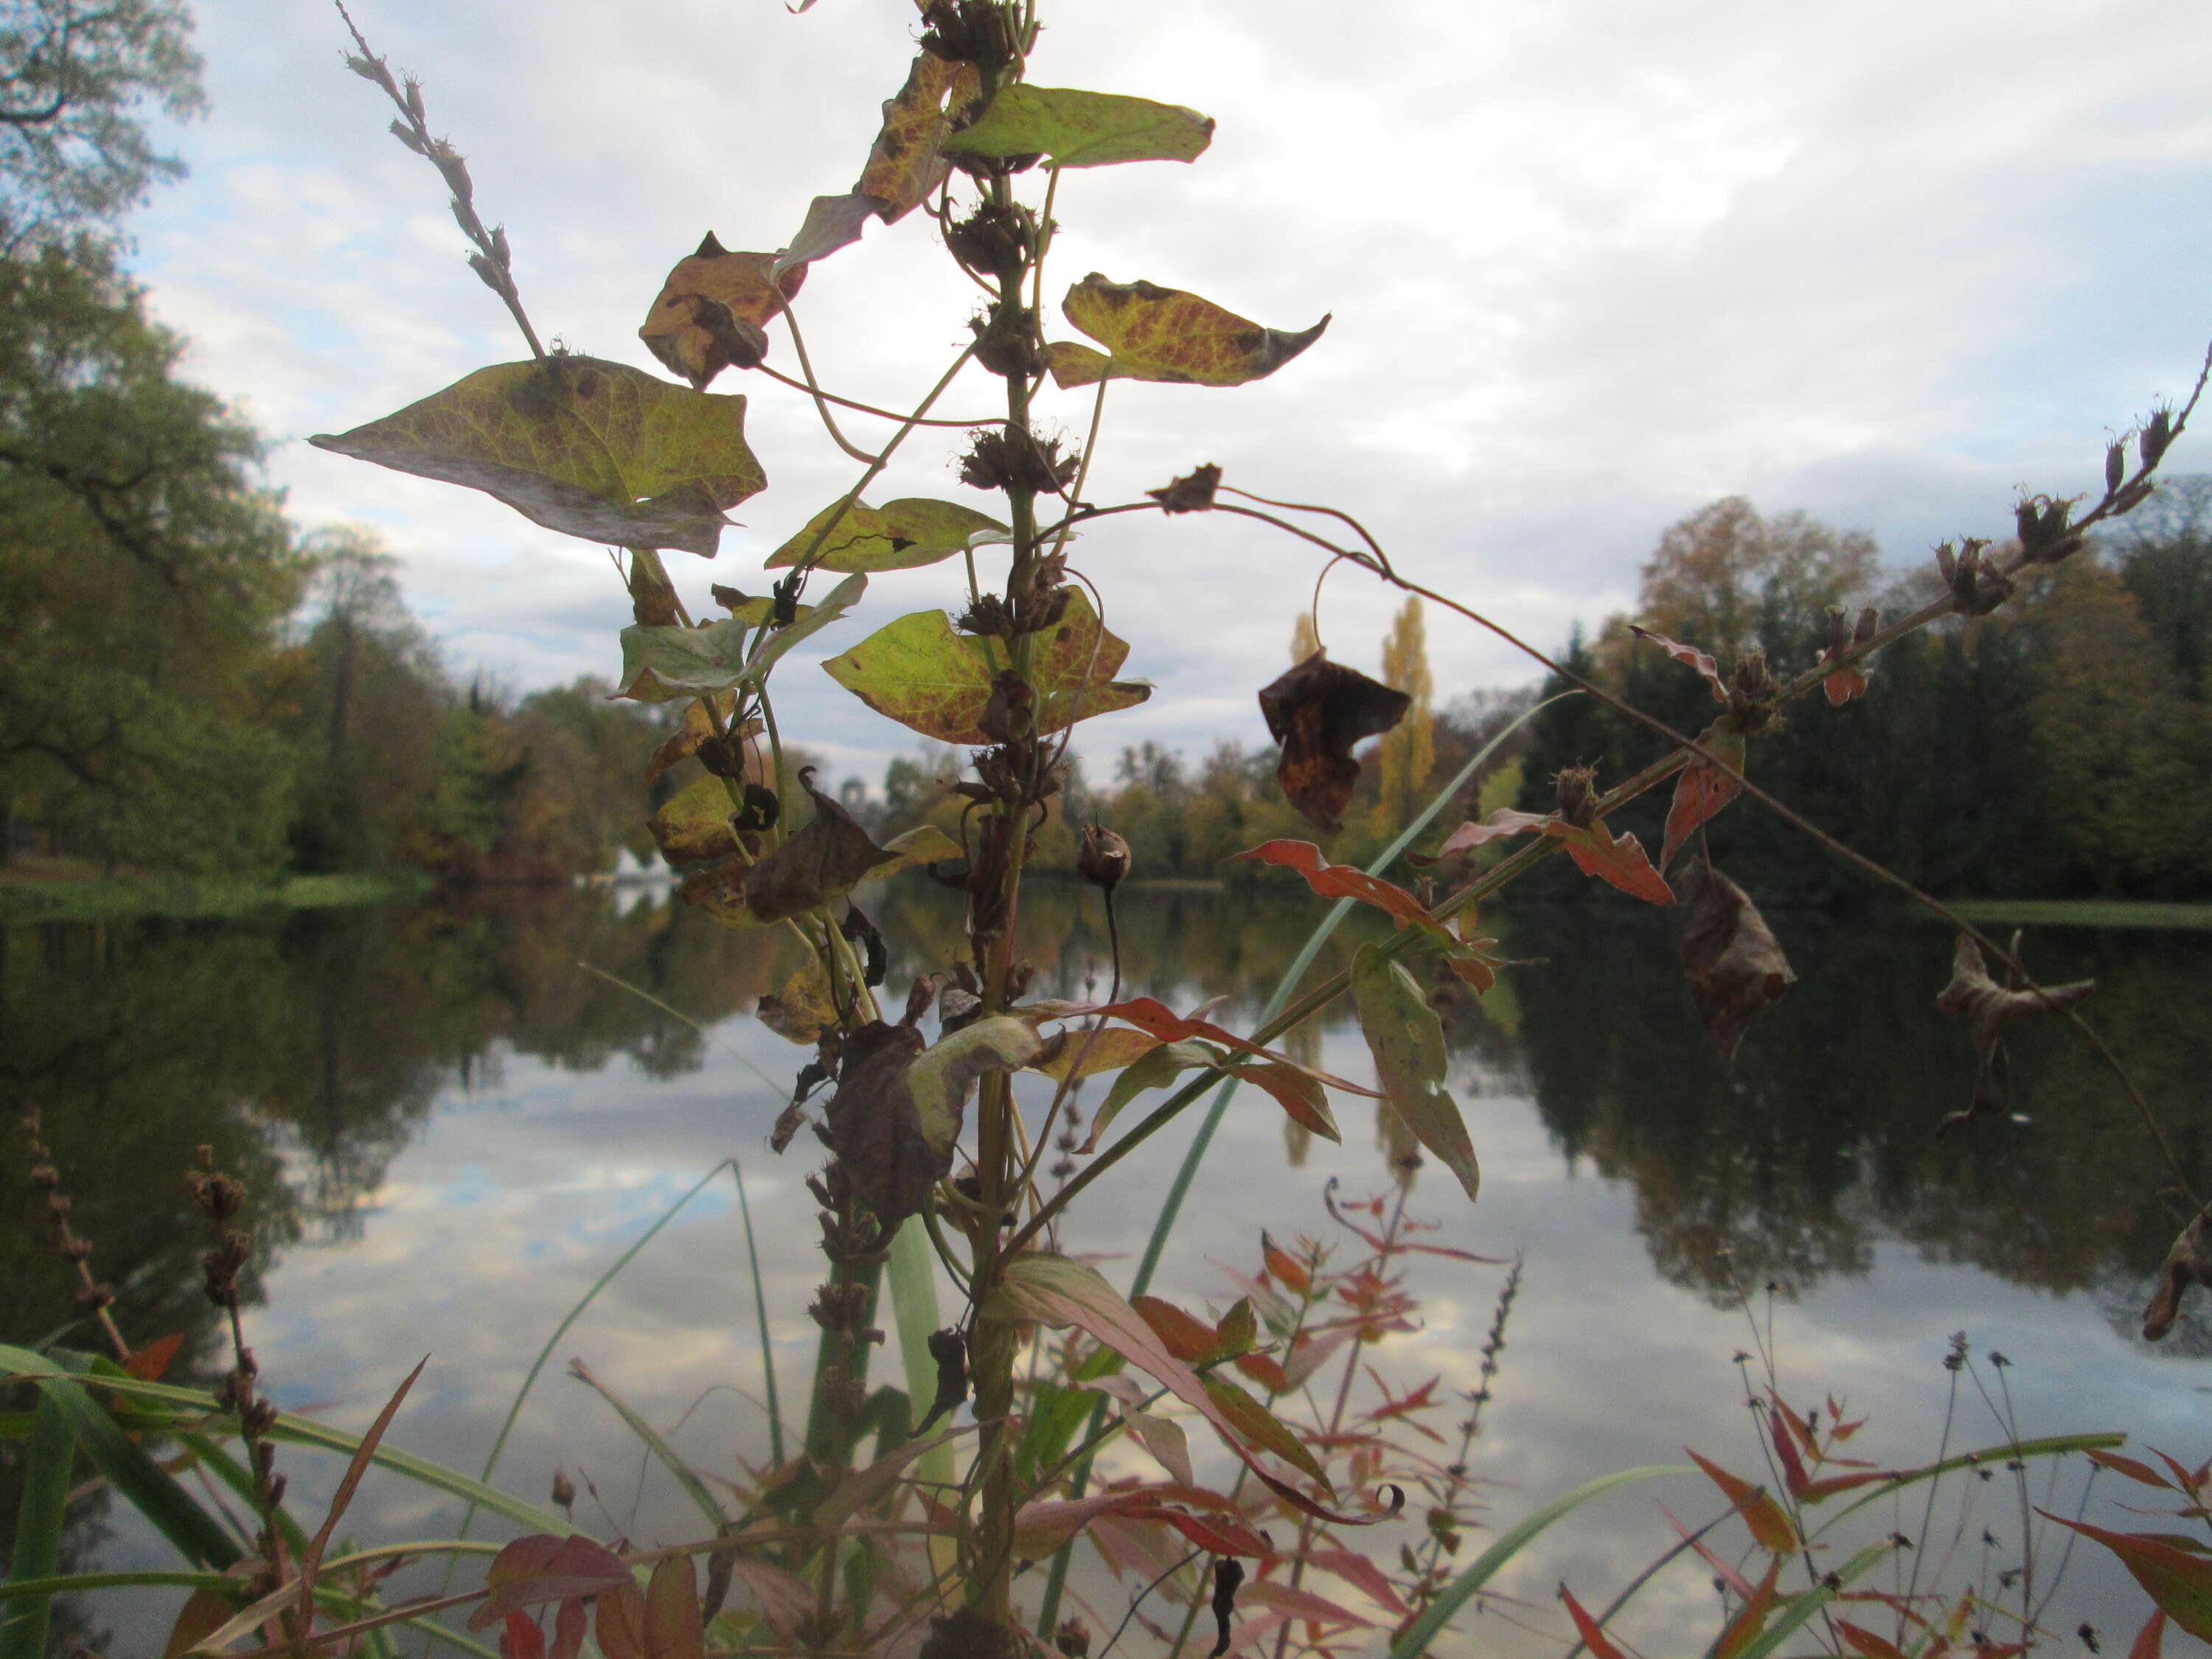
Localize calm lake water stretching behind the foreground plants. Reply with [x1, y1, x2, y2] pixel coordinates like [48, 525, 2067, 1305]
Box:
[0, 883, 2212, 1655]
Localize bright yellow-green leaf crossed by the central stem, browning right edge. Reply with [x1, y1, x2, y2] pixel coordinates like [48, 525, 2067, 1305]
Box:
[823, 577, 1152, 748]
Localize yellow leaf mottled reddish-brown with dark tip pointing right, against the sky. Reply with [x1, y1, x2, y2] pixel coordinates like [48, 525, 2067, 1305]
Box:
[1051, 272, 1329, 387]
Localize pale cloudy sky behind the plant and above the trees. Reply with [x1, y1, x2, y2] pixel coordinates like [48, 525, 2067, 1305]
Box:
[133, 0, 2212, 776]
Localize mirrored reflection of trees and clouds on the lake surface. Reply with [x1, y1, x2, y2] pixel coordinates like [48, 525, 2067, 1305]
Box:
[0, 880, 2212, 1650]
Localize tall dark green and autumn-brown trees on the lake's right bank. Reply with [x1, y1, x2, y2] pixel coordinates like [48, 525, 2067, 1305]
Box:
[1522, 498, 2212, 900]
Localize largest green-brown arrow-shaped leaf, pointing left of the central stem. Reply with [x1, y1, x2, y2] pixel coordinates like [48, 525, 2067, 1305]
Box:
[307, 356, 768, 557]
